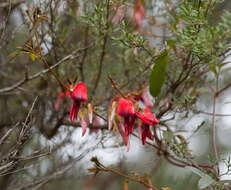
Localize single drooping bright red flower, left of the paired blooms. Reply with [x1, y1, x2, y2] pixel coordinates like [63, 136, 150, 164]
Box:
[70, 82, 87, 121]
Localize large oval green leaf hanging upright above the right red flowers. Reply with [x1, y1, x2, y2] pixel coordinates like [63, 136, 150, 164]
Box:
[149, 50, 168, 97]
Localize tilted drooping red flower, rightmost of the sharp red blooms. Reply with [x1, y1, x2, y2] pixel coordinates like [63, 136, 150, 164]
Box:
[136, 107, 159, 145]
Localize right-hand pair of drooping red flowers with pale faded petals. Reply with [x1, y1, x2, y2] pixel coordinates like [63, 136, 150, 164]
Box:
[108, 98, 159, 150]
